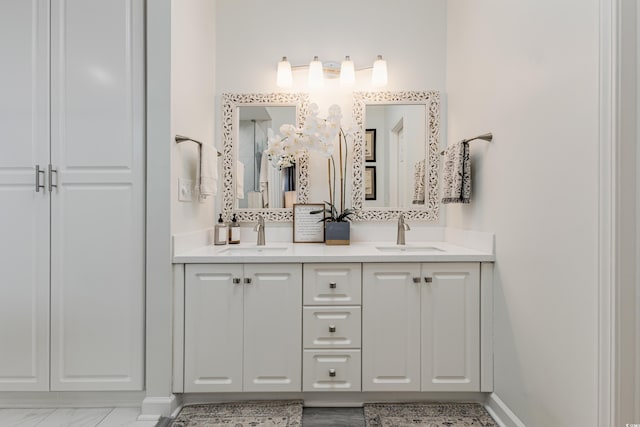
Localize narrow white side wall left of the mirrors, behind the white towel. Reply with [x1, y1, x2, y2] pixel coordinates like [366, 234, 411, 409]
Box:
[171, 0, 216, 234]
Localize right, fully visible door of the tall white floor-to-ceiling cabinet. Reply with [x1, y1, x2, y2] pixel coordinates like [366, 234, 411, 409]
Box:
[51, 0, 145, 390]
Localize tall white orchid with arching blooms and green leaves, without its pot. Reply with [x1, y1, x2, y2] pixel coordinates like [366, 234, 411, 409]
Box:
[266, 104, 354, 222]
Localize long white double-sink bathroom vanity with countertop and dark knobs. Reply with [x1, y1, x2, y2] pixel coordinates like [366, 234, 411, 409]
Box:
[174, 242, 494, 402]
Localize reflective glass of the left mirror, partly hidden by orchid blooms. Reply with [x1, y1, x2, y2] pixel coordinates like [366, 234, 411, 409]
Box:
[235, 105, 296, 209]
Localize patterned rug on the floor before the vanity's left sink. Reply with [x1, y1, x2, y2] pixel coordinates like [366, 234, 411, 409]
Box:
[171, 400, 302, 427]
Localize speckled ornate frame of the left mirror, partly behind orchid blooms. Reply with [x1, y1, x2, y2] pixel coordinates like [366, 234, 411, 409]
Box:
[222, 93, 309, 222]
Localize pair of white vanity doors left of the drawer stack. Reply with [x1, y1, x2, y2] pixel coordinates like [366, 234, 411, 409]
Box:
[184, 264, 302, 392]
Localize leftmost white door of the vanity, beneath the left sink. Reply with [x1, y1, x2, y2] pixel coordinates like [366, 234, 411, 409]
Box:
[184, 264, 244, 392]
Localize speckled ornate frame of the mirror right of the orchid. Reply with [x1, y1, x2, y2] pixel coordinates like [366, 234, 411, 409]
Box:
[351, 91, 440, 221]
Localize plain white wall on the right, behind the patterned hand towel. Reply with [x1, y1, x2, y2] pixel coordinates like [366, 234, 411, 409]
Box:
[447, 0, 599, 427]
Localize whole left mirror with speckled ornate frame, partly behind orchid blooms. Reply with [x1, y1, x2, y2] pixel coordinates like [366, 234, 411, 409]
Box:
[222, 93, 309, 222]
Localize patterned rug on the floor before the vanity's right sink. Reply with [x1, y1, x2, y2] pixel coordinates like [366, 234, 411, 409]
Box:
[364, 403, 498, 427]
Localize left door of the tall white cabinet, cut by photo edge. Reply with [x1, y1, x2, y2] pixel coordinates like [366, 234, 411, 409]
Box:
[0, 0, 49, 391]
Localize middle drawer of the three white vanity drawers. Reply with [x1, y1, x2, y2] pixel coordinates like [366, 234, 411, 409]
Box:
[302, 306, 362, 348]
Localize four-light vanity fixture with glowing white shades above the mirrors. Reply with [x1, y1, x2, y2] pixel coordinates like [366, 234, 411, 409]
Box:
[276, 55, 387, 88]
